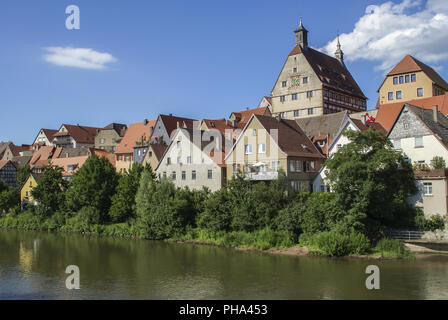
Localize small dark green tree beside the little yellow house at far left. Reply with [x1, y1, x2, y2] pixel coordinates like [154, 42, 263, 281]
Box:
[31, 166, 67, 216]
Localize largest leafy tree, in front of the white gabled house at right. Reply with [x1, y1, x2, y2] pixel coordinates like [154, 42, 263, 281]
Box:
[325, 128, 417, 234]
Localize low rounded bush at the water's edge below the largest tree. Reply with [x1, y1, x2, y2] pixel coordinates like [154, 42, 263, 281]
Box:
[300, 230, 370, 257]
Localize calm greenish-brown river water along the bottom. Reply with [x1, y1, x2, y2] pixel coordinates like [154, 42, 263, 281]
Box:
[0, 230, 448, 300]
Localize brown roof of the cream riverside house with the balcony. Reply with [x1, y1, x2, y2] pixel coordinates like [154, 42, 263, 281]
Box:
[254, 115, 323, 158]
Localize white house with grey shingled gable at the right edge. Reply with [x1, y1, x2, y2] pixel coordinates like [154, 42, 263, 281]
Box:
[388, 104, 448, 168]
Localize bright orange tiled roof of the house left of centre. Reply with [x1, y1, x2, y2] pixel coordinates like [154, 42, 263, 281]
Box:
[115, 120, 156, 154]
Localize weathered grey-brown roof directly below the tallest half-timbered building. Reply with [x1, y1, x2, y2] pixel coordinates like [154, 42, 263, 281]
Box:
[295, 111, 348, 138]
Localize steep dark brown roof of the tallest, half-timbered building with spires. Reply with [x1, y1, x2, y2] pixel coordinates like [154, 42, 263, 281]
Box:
[289, 45, 366, 99]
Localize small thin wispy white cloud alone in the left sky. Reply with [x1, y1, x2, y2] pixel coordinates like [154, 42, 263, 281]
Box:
[44, 47, 117, 70]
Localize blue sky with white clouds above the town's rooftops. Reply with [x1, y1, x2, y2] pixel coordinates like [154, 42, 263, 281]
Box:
[0, 0, 448, 144]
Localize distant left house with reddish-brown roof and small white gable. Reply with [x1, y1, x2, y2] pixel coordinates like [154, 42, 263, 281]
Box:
[52, 124, 101, 148]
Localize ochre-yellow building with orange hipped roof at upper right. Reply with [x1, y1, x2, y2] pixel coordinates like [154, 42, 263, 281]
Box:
[378, 55, 448, 106]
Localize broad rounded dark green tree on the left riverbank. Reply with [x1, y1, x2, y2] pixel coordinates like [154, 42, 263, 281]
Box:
[65, 155, 118, 223]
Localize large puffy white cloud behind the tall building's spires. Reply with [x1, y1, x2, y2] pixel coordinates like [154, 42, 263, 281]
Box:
[321, 0, 448, 71]
